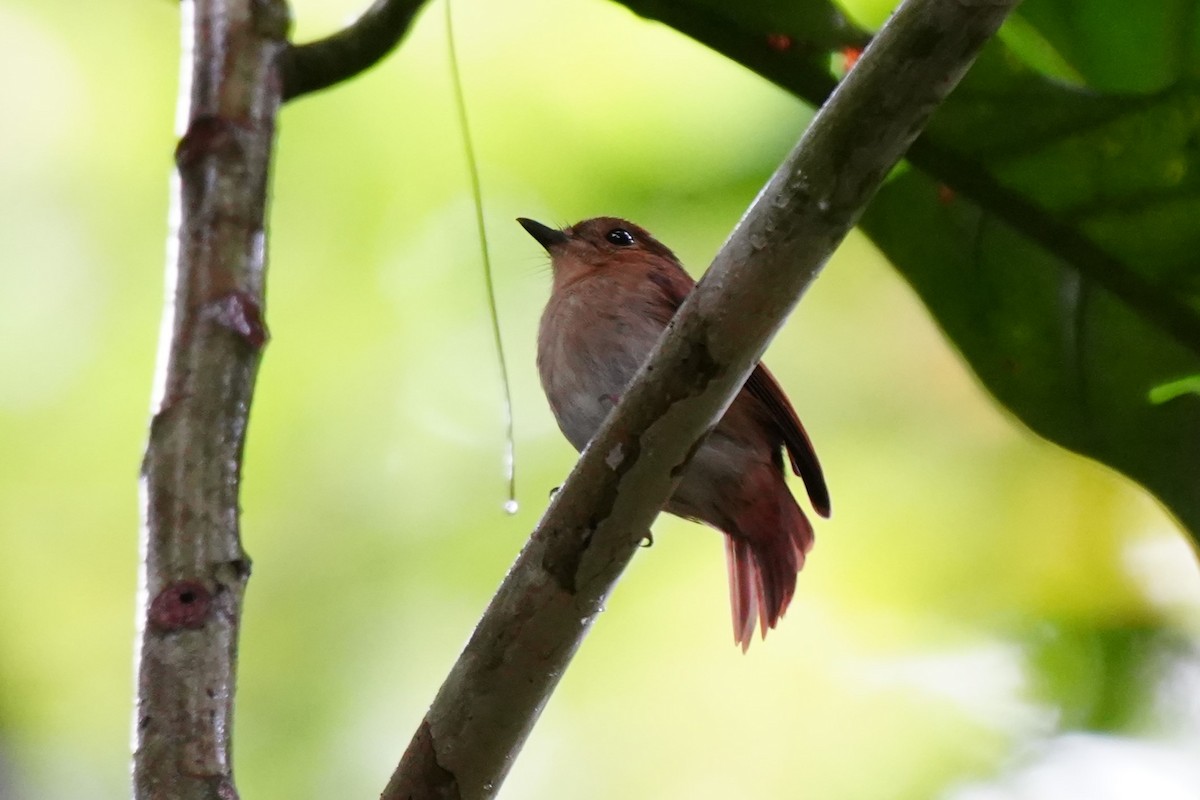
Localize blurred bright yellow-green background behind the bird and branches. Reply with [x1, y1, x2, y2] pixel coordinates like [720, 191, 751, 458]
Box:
[0, 0, 1200, 800]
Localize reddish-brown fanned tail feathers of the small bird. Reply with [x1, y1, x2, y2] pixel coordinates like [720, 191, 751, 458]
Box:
[725, 469, 814, 651]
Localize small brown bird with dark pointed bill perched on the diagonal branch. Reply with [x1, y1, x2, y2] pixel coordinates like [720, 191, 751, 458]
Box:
[517, 217, 829, 650]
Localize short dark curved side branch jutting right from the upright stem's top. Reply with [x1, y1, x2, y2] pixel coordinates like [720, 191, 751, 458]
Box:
[280, 0, 425, 101]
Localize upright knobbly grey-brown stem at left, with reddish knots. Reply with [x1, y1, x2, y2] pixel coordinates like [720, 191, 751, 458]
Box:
[133, 0, 288, 800]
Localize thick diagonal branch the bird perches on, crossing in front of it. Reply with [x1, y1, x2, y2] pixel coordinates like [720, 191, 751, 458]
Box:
[383, 0, 1019, 800]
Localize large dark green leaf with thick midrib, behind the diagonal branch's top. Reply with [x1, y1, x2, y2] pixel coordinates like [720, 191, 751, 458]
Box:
[625, 0, 1200, 541]
